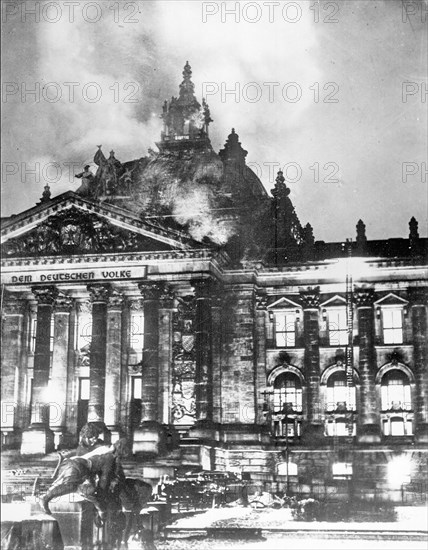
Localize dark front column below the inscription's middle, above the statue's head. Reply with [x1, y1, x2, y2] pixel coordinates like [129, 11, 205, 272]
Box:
[88, 284, 111, 422]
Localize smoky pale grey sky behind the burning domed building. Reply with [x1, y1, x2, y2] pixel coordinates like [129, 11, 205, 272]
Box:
[2, 0, 428, 240]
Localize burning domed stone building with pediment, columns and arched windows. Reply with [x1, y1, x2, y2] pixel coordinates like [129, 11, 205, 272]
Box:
[1, 61, 428, 500]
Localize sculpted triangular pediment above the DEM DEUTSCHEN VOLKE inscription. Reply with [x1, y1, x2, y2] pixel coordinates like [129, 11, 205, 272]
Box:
[1, 192, 200, 258]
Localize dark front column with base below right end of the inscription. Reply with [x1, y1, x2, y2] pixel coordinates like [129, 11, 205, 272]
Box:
[133, 282, 166, 455]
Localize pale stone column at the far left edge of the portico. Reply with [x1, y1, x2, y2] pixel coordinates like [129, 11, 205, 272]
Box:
[1, 295, 25, 447]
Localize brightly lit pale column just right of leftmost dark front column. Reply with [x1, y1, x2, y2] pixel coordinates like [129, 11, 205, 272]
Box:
[49, 294, 73, 447]
